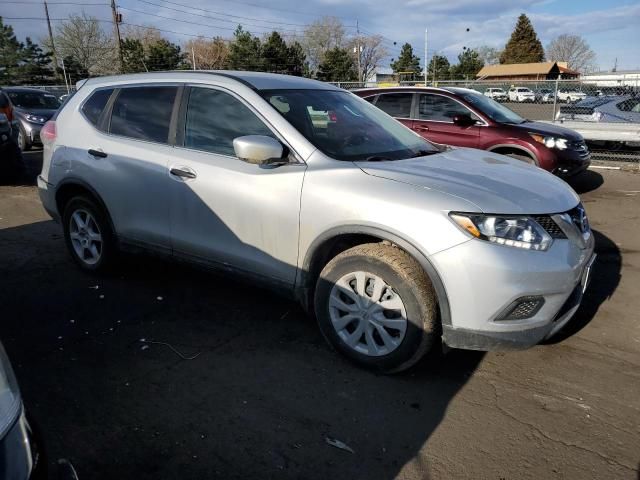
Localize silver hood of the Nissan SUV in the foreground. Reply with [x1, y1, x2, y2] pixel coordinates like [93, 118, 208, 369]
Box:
[356, 148, 580, 215]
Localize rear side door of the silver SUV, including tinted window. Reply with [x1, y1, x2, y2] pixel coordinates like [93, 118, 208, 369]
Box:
[74, 85, 179, 251]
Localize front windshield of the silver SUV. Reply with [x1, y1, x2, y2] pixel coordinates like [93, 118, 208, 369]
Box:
[261, 90, 440, 161]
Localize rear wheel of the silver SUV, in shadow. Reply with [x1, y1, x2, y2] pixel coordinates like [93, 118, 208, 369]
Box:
[62, 196, 116, 272]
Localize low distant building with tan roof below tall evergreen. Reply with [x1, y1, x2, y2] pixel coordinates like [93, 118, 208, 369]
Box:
[476, 62, 580, 81]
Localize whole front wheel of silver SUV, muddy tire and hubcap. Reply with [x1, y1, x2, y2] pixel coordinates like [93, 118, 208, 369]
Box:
[314, 243, 440, 373]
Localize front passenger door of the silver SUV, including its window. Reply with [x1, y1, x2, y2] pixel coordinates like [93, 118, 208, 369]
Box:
[169, 87, 306, 285]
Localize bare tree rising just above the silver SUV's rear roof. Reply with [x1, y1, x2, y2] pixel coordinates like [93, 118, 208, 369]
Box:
[47, 12, 118, 75]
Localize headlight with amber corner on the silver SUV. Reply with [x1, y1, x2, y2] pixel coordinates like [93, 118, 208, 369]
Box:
[449, 212, 553, 251]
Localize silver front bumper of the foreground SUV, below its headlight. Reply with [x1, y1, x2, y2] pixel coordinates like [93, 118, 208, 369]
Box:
[431, 228, 595, 350]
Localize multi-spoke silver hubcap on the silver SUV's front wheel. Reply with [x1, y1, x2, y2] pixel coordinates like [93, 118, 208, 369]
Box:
[329, 272, 407, 357]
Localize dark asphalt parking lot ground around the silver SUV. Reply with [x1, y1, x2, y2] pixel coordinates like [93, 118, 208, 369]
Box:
[0, 152, 640, 480]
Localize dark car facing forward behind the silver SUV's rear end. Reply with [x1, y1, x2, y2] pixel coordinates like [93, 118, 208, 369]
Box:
[3, 87, 60, 151]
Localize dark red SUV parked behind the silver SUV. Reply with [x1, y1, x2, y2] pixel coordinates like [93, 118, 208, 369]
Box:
[353, 87, 591, 177]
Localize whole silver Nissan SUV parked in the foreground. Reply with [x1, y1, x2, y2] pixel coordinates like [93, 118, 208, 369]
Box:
[38, 71, 594, 372]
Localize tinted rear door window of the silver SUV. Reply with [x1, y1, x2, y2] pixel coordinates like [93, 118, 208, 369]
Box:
[110, 86, 178, 143]
